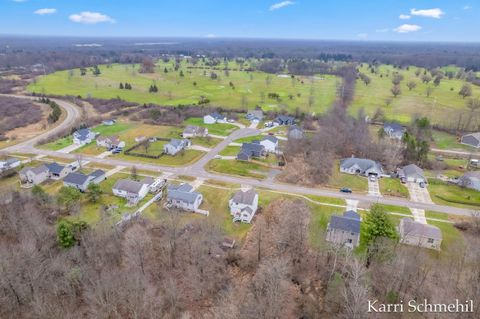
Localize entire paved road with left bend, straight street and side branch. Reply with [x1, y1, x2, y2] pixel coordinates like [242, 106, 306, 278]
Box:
[4, 95, 472, 216]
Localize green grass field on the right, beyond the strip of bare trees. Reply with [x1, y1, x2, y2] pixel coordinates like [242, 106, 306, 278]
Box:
[350, 64, 480, 123]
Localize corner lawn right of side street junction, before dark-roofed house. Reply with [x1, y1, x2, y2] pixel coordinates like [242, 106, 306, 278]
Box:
[206, 159, 268, 180]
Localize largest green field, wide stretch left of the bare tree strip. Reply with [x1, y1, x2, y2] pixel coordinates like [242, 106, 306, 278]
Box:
[28, 60, 338, 113]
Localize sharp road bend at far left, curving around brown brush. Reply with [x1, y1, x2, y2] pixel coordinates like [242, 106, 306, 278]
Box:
[0, 94, 81, 153]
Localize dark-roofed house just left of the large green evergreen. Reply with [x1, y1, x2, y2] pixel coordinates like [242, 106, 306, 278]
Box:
[326, 210, 362, 248]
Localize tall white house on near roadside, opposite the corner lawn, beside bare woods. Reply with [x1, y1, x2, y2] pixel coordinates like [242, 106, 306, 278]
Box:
[228, 189, 258, 224]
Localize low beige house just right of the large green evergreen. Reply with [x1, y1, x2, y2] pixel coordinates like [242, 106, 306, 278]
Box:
[398, 217, 442, 250]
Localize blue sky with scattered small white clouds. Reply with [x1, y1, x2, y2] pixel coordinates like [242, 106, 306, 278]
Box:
[0, 0, 480, 42]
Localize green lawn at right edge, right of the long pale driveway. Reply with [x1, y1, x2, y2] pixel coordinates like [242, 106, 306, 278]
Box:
[428, 179, 480, 210]
